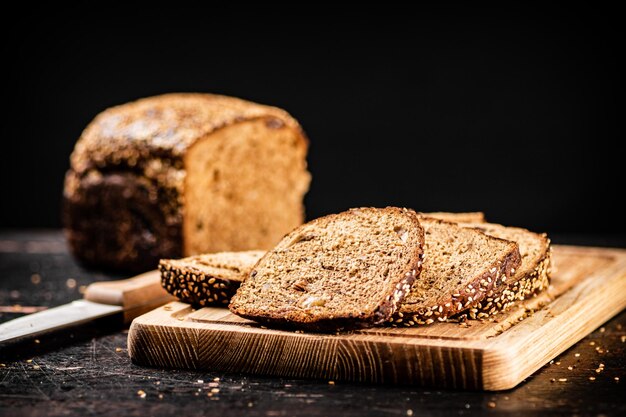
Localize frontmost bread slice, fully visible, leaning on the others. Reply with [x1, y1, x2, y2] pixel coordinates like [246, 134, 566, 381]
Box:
[230, 207, 424, 331]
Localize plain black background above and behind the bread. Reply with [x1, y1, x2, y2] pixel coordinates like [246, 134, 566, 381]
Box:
[0, 3, 626, 233]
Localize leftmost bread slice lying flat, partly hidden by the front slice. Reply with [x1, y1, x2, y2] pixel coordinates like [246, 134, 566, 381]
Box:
[159, 250, 265, 306]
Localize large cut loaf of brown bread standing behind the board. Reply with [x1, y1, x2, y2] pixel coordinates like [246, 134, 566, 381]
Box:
[64, 94, 310, 271]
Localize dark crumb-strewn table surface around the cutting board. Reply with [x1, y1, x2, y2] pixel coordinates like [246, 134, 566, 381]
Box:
[0, 231, 626, 417]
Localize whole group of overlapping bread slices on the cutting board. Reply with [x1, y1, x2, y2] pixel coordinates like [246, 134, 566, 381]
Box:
[159, 208, 551, 330]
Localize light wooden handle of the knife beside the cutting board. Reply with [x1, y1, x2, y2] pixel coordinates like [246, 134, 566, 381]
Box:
[85, 270, 176, 323]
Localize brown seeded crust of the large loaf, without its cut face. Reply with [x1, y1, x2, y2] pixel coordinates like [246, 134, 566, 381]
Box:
[63, 94, 307, 271]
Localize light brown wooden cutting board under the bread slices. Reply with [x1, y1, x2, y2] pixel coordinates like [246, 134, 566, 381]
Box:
[128, 246, 626, 390]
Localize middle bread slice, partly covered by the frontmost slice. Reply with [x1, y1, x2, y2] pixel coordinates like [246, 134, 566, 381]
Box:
[393, 217, 521, 326]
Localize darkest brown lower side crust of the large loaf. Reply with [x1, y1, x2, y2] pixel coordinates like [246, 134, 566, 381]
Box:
[63, 172, 182, 272]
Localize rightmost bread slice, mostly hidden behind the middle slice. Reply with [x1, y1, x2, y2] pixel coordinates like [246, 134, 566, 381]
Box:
[454, 223, 552, 319]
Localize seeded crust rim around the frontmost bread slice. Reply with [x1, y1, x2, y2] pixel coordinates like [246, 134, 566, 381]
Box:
[229, 207, 424, 332]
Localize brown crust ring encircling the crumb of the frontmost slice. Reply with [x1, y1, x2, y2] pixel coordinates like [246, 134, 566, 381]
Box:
[229, 207, 424, 332]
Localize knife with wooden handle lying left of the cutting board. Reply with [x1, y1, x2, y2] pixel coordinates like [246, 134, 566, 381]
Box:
[0, 270, 176, 348]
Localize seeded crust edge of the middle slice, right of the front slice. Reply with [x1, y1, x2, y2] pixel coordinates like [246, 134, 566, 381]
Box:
[389, 217, 521, 326]
